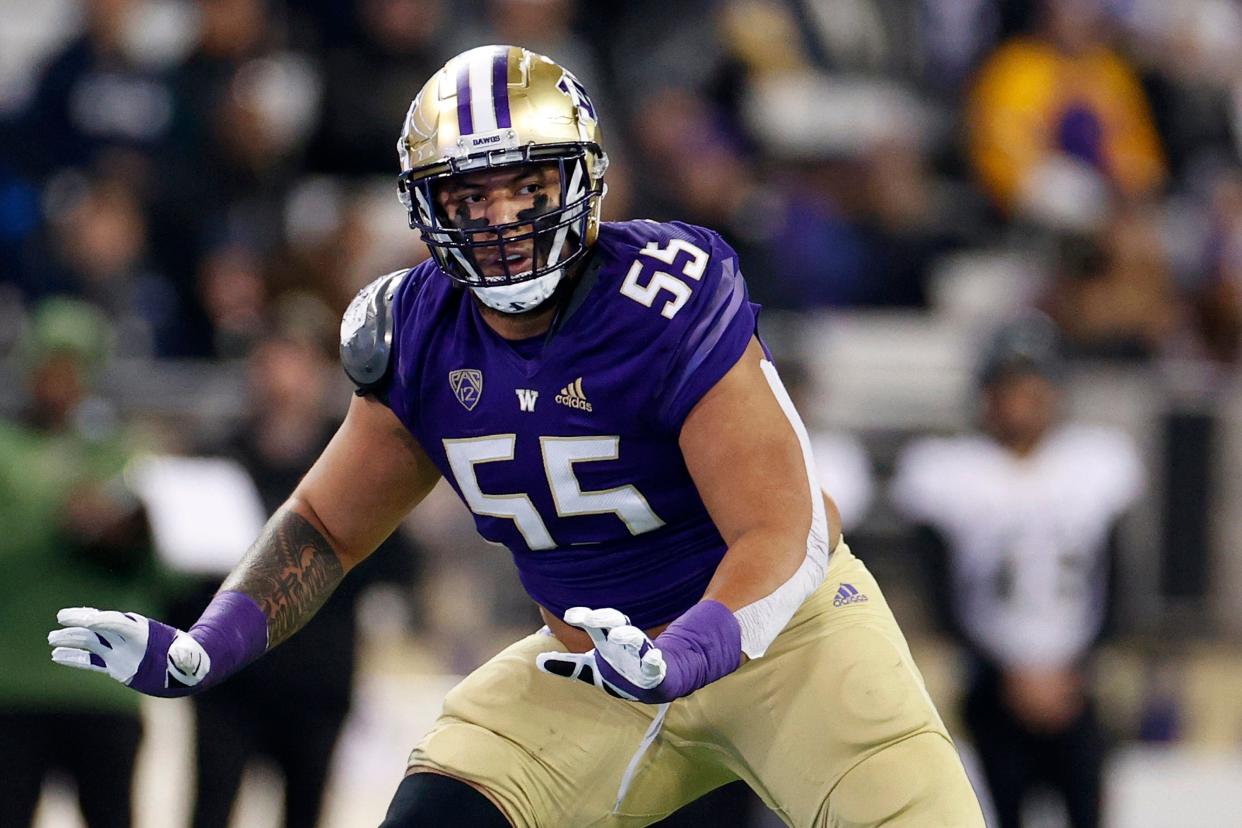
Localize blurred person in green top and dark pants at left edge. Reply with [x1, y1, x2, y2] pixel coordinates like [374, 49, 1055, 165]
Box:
[0, 299, 160, 828]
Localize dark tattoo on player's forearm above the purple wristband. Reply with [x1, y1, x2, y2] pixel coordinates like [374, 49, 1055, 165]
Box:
[220, 509, 345, 649]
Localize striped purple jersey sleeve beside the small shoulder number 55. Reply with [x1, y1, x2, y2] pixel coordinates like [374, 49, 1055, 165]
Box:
[657, 225, 759, 431]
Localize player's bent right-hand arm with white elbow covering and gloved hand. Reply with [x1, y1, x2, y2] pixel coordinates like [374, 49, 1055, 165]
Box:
[539, 340, 840, 703]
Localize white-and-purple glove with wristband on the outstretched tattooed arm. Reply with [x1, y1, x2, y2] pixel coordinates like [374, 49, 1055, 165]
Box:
[47, 591, 267, 698]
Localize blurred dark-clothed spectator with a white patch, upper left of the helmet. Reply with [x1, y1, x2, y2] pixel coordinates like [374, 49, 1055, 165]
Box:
[153, 0, 319, 299]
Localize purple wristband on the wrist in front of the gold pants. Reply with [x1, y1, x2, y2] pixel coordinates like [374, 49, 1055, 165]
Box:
[653, 601, 741, 699]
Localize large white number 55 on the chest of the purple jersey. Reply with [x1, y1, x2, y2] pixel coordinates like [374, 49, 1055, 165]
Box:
[443, 434, 664, 549]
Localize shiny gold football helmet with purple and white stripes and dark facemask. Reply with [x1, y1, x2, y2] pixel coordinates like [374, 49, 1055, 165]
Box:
[397, 46, 609, 313]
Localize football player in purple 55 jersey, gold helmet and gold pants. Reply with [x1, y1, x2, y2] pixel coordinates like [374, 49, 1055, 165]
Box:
[51, 46, 982, 827]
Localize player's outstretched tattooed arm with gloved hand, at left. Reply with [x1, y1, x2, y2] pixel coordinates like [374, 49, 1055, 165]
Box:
[48, 396, 438, 696]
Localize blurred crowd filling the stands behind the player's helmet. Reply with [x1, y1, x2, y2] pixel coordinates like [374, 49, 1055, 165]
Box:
[0, 0, 1242, 364]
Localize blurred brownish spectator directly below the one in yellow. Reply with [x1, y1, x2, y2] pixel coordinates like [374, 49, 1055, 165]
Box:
[1049, 205, 1184, 359]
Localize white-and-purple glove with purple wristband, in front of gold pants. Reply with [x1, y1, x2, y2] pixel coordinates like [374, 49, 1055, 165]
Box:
[535, 601, 741, 704]
